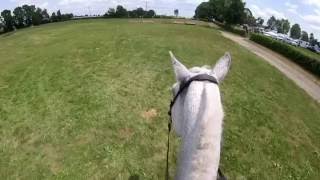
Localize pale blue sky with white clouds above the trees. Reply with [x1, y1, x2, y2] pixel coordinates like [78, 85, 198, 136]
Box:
[0, 0, 320, 39]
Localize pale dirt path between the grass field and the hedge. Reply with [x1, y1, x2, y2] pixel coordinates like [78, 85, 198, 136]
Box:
[221, 32, 320, 103]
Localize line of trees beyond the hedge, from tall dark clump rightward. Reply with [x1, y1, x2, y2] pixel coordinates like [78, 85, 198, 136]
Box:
[194, 0, 318, 45]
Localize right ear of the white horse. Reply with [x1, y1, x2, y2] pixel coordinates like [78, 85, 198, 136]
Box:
[211, 52, 231, 83]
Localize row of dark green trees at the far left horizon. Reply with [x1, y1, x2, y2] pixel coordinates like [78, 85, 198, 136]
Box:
[0, 5, 73, 32]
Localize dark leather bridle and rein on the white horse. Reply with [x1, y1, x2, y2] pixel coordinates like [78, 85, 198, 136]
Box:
[166, 74, 227, 180]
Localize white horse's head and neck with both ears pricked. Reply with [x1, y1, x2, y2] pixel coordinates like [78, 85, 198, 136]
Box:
[170, 52, 231, 180]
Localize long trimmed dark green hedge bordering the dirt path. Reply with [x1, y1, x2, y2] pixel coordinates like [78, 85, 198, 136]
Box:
[250, 34, 320, 77]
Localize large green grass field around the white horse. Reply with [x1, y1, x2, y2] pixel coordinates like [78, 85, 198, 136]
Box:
[0, 20, 320, 180]
